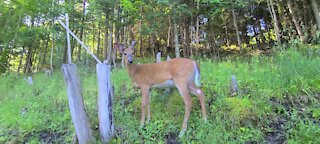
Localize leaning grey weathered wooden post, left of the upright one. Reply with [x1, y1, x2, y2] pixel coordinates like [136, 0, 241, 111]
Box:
[61, 64, 94, 144]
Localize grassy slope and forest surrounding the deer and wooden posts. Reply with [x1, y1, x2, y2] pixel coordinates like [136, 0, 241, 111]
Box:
[0, 0, 320, 143]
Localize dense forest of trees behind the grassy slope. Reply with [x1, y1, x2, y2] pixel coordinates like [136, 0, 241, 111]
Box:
[0, 0, 320, 74]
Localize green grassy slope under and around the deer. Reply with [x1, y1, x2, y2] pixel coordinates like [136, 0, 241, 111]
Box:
[0, 50, 320, 143]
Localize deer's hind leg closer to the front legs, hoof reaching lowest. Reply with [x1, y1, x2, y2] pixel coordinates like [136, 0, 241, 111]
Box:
[177, 83, 192, 137]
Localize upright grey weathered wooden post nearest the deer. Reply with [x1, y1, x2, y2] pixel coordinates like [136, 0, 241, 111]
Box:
[97, 63, 114, 143]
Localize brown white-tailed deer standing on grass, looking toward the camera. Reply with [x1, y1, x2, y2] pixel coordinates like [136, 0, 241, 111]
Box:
[115, 41, 207, 136]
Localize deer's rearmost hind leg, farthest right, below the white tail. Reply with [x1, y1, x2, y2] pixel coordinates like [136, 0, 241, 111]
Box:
[189, 82, 207, 122]
